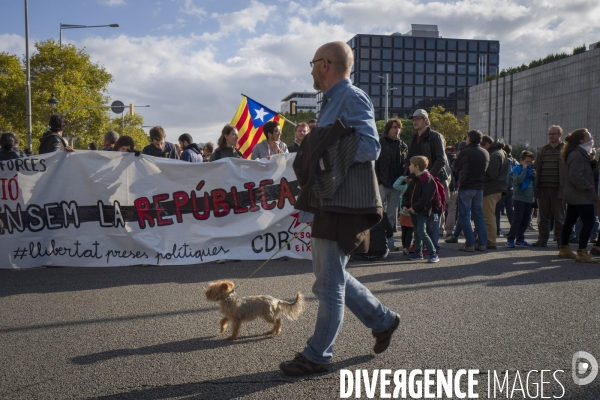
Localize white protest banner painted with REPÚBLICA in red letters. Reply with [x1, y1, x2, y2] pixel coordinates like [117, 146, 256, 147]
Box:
[0, 150, 311, 269]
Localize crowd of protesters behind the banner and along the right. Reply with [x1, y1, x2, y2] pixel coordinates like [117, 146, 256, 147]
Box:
[0, 109, 600, 262]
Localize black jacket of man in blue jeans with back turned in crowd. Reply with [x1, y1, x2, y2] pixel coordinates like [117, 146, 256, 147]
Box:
[452, 143, 490, 190]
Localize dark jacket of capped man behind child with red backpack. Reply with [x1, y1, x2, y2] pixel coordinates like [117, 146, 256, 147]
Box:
[404, 127, 447, 178]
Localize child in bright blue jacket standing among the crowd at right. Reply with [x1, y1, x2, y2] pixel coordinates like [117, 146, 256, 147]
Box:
[506, 150, 535, 248]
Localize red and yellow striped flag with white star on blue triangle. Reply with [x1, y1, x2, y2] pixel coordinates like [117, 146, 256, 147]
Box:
[231, 95, 284, 158]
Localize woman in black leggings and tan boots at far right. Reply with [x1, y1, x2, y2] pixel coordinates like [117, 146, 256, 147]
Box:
[558, 129, 600, 262]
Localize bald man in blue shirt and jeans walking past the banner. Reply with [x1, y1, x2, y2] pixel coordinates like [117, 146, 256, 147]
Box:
[279, 42, 400, 376]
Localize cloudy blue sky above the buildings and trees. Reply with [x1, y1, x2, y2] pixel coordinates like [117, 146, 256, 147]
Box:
[0, 0, 600, 142]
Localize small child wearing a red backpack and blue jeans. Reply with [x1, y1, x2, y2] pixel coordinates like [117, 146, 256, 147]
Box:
[402, 156, 439, 263]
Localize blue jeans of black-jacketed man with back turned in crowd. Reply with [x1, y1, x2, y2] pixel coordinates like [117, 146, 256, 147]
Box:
[458, 190, 487, 246]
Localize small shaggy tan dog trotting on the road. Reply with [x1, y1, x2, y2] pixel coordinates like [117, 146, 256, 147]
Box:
[204, 281, 304, 340]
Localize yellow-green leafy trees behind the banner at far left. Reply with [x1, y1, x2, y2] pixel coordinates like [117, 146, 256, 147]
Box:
[0, 39, 149, 151]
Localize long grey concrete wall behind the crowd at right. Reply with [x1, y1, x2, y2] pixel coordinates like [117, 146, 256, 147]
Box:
[469, 48, 600, 148]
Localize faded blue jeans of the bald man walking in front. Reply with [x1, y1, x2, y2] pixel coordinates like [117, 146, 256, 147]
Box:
[302, 237, 396, 364]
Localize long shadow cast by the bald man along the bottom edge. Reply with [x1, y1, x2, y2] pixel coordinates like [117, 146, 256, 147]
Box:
[88, 355, 375, 400]
